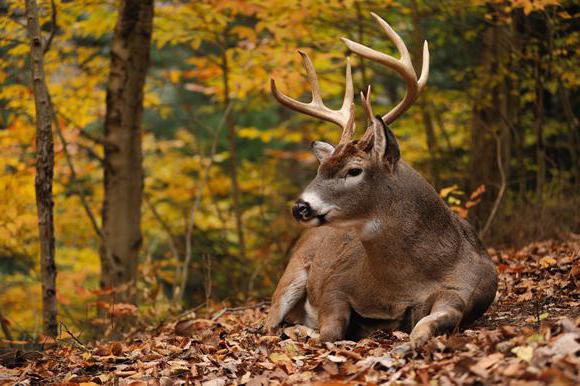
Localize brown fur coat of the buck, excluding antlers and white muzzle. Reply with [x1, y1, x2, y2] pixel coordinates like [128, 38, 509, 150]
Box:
[267, 119, 497, 347]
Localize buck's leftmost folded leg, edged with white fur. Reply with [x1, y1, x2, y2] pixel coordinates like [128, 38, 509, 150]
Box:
[265, 256, 308, 332]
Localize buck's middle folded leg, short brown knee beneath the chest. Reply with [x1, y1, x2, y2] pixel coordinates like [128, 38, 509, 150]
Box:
[318, 296, 351, 342]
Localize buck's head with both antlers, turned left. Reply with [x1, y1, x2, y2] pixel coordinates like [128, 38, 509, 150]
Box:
[271, 13, 429, 226]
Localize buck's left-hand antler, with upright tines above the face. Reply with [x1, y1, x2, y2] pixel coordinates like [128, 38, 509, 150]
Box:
[270, 50, 355, 143]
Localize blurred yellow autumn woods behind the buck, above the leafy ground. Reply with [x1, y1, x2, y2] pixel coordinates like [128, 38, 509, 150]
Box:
[0, 0, 580, 340]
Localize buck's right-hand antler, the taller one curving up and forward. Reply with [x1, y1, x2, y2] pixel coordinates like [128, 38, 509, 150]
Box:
[341, 12, 429, 126]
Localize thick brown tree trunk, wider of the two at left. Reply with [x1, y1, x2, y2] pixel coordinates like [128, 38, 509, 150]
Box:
[101, 0, 153, 303]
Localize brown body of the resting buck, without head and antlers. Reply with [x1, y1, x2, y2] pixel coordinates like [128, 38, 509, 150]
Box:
[269, 159, 497, 345]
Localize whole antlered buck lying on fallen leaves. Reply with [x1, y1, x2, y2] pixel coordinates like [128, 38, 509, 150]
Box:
[266, 13, 497, 349]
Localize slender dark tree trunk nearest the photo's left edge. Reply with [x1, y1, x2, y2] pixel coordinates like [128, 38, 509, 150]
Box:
[26, 0, 58, 337]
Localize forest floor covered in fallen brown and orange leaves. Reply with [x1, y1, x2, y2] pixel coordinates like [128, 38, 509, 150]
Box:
[0, 237, 580, 386]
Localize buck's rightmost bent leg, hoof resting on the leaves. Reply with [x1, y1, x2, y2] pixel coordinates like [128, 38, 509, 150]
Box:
[410, 291, 465, 349]
